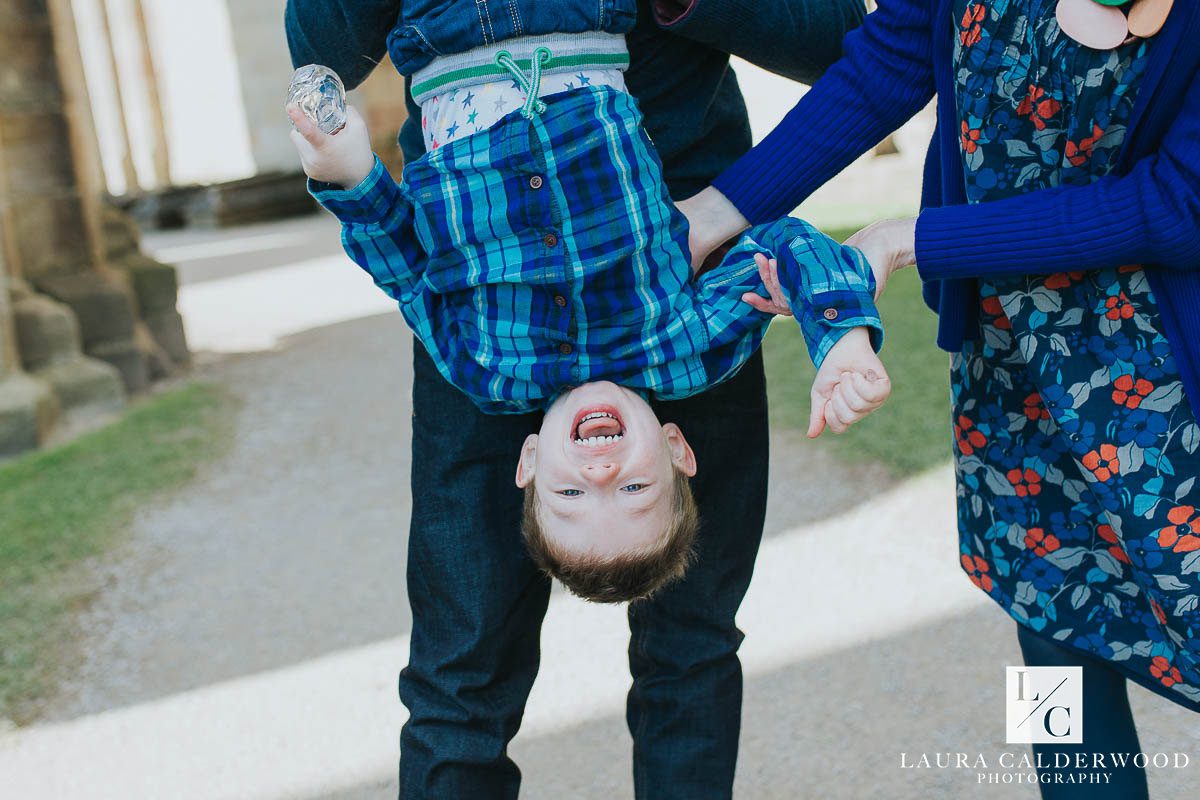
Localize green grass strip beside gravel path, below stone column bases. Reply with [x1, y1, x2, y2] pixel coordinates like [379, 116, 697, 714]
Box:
[0, 384, 235, 723]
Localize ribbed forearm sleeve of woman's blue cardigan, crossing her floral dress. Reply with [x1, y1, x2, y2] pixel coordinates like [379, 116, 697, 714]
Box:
[916, 177, 1153, 281]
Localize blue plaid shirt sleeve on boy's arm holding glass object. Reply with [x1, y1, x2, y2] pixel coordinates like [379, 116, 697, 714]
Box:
[308, 156, 425, 308]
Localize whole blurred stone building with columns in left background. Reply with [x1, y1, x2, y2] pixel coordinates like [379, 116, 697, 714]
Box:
[0, 0, 404, 456]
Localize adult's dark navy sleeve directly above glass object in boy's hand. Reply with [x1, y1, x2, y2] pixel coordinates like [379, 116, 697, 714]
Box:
[283, 0, 401, 89]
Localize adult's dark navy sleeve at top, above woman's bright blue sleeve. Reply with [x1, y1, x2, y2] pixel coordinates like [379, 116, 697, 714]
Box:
[653, 0, 866, 84]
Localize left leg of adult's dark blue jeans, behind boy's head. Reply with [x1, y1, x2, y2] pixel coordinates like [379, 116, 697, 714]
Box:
[400, 344, 550, 800]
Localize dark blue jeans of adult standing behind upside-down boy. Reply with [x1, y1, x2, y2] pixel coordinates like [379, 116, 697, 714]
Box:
[400, 344, 768, 800]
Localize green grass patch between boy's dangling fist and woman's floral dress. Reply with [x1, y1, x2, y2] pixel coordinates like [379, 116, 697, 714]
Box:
[763, 230, 950, 476]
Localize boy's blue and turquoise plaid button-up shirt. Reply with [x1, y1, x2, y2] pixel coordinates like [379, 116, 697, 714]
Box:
[310, 88, 882, 414]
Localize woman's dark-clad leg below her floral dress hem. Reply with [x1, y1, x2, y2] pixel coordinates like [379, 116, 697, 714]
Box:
[1016, 625, 1150, 800]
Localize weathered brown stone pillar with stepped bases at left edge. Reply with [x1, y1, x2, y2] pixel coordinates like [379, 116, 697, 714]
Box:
[0, 0, 187, 456]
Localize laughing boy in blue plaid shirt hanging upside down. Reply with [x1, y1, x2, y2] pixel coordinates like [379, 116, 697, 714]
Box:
[288, 34, 890, 602]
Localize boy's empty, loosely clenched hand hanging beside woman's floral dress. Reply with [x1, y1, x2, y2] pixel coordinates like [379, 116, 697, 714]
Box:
[809, 327, 892, 439]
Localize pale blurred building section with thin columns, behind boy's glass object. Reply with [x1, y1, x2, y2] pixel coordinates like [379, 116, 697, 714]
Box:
[72, 0, 404, 221]
